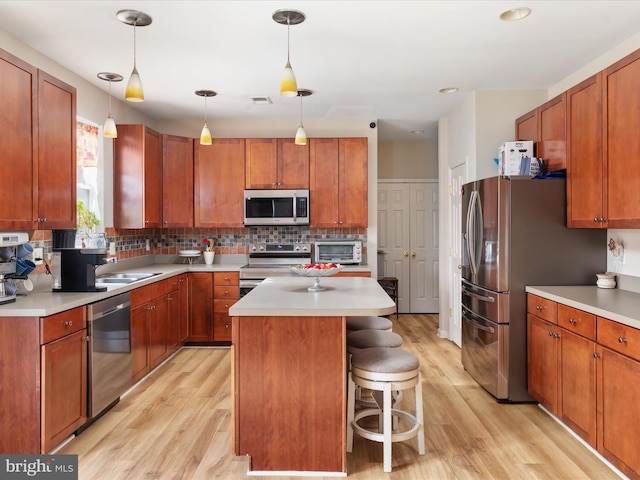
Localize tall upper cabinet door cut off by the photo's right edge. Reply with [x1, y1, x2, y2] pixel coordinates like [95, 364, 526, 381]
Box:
[602, 50, 640, 228]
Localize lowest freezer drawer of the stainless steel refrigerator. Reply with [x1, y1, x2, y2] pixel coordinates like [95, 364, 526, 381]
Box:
[462, 305, 509, 400]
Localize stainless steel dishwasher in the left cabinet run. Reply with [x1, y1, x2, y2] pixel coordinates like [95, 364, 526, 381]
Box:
[87, 292, 131, 419]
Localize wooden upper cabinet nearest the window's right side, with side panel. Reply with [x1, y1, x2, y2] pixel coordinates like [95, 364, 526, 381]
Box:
[113, 125, 162, 229]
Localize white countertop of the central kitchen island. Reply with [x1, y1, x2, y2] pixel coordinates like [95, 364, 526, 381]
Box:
[229, 277, 396, 317]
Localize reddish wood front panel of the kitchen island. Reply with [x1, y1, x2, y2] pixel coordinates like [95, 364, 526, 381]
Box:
[233, 316, 346, 472]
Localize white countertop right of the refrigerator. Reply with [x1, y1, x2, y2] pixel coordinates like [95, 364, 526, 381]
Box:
[526, 285, 640, 328]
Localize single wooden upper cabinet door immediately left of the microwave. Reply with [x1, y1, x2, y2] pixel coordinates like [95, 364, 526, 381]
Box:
[194, 138, 245, 227]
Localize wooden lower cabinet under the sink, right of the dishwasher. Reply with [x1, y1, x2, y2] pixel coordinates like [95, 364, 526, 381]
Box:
[131, 278, 180, 382]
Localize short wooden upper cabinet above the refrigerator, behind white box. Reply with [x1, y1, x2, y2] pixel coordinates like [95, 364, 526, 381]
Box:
[516, 93, 567, 172]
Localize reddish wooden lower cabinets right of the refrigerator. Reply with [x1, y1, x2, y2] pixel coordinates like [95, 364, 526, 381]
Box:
[527, 294, 640, 479]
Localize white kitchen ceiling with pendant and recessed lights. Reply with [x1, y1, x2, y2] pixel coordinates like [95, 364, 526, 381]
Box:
[0, 0, 640, 140]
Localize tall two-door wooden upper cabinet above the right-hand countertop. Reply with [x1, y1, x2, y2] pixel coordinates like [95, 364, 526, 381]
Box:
[567, 50, 640, 228]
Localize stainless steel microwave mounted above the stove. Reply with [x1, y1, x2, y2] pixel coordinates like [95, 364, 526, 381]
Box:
[244, 190, 309, 225]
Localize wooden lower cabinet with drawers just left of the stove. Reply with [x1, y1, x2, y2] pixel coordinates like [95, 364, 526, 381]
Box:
[187, 272, 240, 344]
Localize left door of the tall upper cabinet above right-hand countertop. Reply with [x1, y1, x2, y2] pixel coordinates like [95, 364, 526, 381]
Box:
[567, 74, 606, 228]
